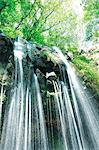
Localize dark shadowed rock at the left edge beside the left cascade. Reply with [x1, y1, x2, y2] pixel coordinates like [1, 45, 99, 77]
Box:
[0, 33, 14, 100]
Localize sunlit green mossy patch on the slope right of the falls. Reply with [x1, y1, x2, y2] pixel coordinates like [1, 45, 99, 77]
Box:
[73, 55, 99, 93]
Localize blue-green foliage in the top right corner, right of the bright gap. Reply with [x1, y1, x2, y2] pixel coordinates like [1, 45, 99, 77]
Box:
[84, 0, 99, 42]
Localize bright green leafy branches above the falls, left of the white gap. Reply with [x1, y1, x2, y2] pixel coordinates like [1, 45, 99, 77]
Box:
[0, 0, 76, 47]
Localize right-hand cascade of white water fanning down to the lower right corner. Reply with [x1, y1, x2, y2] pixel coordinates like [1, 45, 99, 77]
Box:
[53, 47, 99, 150]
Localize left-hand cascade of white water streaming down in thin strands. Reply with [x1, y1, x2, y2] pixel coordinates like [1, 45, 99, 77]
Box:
[0, 38, 48, 150]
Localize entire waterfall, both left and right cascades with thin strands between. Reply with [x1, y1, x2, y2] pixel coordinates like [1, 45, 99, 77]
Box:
[0, 38, 99, 150]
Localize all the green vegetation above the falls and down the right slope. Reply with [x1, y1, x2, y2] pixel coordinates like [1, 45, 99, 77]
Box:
[0, 0, 99, 92]
